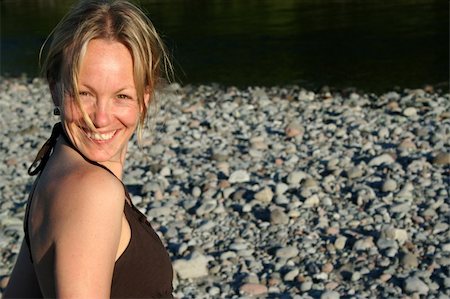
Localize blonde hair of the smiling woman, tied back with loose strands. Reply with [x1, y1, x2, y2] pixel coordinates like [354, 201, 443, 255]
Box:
[41, 0, 173, 142]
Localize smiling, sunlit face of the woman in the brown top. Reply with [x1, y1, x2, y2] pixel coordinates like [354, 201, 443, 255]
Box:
[62, 39, 148, 162]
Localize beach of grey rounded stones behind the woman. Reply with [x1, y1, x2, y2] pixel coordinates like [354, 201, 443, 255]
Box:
[0, 78, 450, 299]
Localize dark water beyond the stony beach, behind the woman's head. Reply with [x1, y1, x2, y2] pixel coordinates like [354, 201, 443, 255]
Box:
[0, 0, 449, 92]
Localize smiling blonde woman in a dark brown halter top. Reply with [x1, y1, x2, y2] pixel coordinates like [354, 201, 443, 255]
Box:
[4, 0, 172, 298]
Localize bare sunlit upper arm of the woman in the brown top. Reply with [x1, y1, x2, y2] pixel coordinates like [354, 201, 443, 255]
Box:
[49, 170, 125, 298]
